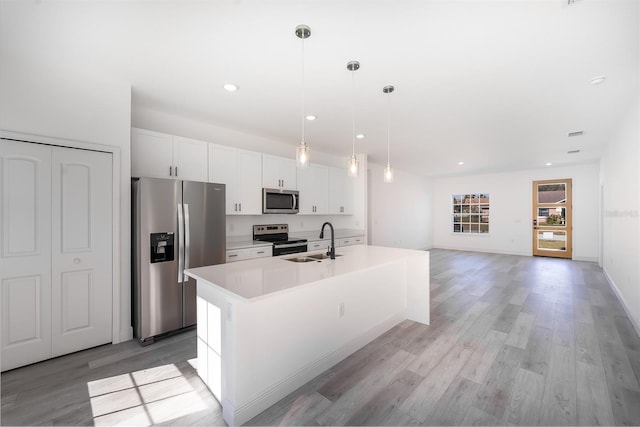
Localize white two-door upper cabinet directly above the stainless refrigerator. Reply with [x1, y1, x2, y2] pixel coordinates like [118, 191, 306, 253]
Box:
[131, 128, 207, 182]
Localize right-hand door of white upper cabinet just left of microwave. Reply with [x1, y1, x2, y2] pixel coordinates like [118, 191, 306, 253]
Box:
[235, 150, 262, 215]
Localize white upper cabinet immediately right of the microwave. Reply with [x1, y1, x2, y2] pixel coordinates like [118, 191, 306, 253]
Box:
[297, 164, 329, 215]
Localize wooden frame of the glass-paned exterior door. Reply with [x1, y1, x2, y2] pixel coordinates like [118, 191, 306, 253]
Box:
[531, 178, 573, 259]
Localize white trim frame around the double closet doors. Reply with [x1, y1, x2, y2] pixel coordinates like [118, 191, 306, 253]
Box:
[0, 129, 122, 344]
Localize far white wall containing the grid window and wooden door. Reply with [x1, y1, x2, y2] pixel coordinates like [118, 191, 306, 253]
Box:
[433, 164, 599, 261]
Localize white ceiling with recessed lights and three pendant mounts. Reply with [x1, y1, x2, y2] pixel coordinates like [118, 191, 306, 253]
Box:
[0, 0, 640, 176]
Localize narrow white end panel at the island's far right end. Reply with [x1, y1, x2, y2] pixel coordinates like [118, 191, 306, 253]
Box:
[406, 252, 431, 325]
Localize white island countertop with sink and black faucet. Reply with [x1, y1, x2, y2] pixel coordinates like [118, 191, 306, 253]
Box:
[185, 245, 425, 302]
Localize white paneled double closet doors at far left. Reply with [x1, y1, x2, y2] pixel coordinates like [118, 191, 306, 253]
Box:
[0, 141, 113, 371]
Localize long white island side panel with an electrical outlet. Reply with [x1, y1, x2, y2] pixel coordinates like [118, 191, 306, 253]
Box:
[232, 260, 407, 424]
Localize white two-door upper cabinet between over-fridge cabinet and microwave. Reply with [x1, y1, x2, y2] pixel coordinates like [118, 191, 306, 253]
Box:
[209, 144, 262, 215]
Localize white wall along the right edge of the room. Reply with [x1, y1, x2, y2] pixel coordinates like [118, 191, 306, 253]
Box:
[601, 97, 640, 331]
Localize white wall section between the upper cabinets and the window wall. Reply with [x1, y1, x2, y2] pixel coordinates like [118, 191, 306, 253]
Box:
[368, 163, 433, 249]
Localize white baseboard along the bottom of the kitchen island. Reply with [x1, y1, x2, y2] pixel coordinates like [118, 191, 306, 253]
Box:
[229, 313, 406, 425]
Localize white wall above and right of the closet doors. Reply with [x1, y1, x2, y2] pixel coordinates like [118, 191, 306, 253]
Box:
[0, 53, 132, 340]
